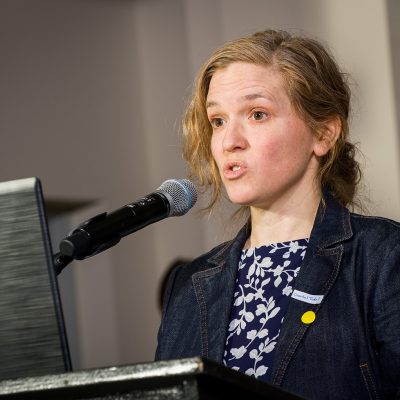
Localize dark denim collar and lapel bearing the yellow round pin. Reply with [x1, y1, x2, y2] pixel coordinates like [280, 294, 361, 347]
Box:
[272, 195, 352, 385]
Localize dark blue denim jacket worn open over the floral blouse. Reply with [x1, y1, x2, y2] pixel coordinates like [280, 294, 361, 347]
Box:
[156, 195, 400, 400]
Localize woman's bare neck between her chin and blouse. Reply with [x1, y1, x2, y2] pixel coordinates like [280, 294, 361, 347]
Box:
[245, 187, 321, 248]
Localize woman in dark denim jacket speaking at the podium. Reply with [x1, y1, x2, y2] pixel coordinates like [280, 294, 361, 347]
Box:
[156, 31, 400, 399]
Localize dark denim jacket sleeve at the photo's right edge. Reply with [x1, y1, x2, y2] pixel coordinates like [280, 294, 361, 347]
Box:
[373, 235, 400, 399]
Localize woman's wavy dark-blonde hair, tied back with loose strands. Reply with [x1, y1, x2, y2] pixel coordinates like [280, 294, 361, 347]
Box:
[183, 30, 361, 210]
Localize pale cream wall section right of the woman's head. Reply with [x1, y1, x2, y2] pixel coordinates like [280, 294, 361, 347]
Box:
[321, 0, 400, 219]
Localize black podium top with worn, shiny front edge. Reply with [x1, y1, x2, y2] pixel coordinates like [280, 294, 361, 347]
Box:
[0, 358, 301, 400]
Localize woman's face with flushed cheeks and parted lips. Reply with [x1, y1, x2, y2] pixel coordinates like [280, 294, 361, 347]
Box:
[207, 62, 320, 209]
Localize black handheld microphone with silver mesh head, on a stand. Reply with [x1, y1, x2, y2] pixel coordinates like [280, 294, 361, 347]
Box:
[60, 179, 197, 260]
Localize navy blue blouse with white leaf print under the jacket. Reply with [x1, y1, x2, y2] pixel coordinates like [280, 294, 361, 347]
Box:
[223, 239, 308, 382]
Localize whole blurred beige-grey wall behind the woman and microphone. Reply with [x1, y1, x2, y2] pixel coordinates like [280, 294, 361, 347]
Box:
[0, 0, 400, 367]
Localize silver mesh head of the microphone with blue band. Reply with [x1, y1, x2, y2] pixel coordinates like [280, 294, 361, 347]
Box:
[157, 179, 197, 217]
